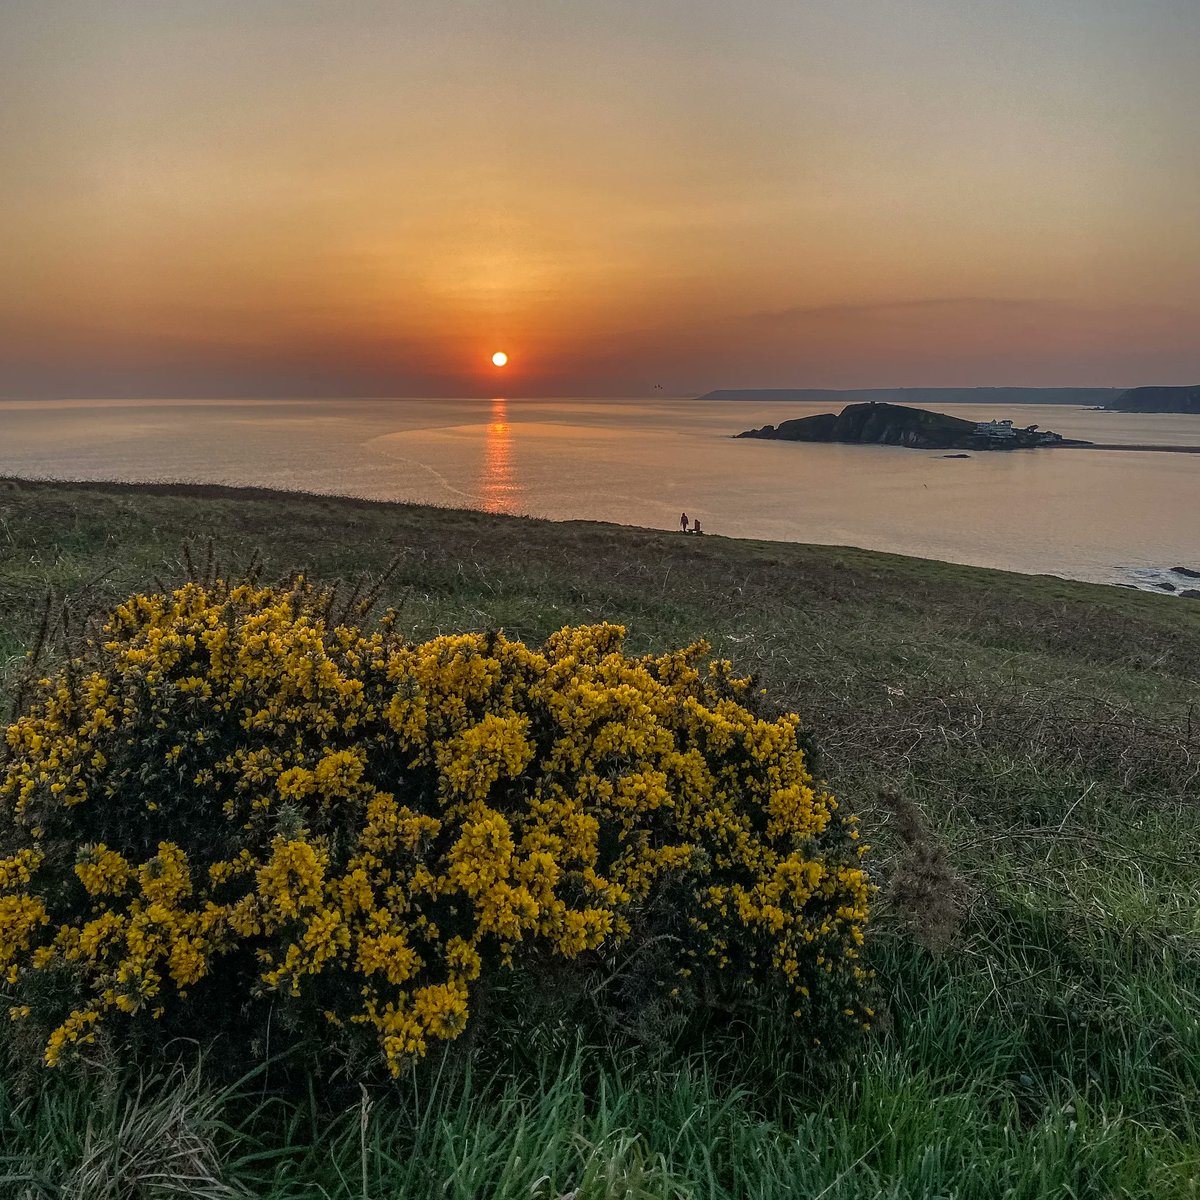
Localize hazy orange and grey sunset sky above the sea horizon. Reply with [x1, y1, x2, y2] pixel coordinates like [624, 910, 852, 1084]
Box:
[0, 0, 1200, 397]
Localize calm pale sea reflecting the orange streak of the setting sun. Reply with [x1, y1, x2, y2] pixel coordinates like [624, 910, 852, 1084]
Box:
[0, 400, 1200, 586]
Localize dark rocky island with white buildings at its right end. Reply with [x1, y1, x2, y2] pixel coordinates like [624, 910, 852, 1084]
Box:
[734, 403, 1087, 450]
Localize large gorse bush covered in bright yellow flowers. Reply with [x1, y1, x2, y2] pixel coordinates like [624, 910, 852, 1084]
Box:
[0, 581, 870, 1073]
